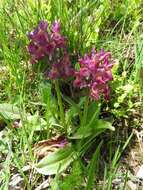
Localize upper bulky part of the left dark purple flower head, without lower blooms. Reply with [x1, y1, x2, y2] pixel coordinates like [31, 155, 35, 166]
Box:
[28, 21, 66, 63]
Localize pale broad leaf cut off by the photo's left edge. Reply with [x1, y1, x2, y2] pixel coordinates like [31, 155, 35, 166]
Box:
[0, 103, 20, 120]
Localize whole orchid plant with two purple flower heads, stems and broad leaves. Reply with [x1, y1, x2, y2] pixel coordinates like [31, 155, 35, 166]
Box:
[28, 21, 114, 174]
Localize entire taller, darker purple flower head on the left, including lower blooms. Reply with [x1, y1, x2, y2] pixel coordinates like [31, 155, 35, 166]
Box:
[28, 21, 73, 79]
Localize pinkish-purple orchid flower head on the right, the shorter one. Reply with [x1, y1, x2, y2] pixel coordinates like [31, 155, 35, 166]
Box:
[74, 49, 113, 100]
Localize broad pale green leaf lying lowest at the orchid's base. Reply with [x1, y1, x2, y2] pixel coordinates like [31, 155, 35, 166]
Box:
[35, 146, 76, 175]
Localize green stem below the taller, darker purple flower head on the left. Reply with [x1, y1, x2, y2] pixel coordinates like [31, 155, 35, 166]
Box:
[55, 80, 65, 127]
